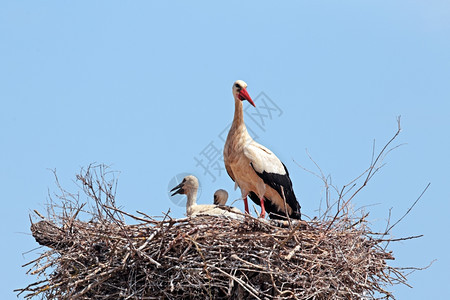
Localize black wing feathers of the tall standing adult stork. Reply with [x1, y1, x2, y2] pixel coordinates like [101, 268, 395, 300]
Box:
[249, 163, 301, 220]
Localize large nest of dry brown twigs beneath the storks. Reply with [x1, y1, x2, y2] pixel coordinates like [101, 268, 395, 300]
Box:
[16, 162, 422, 299]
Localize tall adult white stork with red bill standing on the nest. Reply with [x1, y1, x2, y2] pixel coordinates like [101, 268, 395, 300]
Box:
[223, 80, 301, 220]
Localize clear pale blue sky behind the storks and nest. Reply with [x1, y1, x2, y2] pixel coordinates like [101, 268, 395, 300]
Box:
[0, 0, 450, 299]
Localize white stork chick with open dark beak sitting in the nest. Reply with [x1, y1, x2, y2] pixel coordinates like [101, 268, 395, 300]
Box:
[170, 175, 240, 218]
